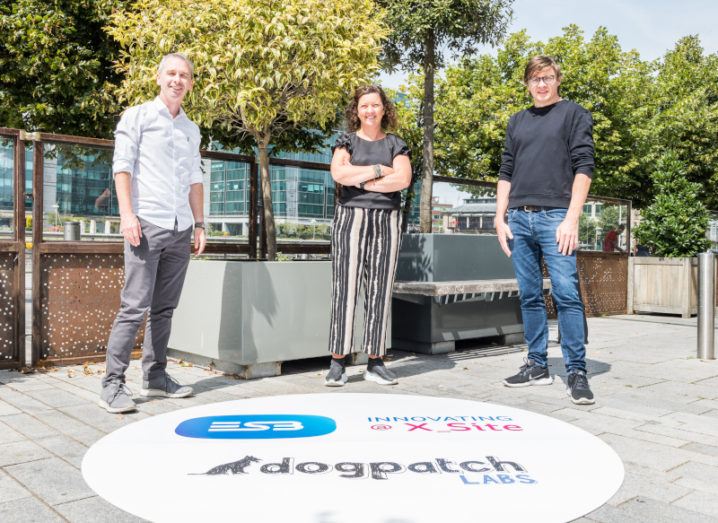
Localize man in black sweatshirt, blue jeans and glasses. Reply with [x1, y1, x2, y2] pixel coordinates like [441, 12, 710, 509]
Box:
[495, 56, 594, 405]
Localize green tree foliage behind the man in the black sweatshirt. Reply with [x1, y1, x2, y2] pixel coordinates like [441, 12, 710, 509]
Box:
[408, 25, 718, 208]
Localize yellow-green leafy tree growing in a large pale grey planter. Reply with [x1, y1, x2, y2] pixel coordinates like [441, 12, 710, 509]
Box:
[109, 0, 386, 377]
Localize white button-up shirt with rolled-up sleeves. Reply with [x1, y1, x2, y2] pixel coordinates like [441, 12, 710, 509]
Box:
[112, 97, 202, 231]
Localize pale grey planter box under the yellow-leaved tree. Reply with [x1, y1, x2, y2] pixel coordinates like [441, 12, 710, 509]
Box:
[169, 260, 374, 378]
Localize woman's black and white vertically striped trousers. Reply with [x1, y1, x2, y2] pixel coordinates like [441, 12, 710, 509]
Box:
[329, 205, 401, 356]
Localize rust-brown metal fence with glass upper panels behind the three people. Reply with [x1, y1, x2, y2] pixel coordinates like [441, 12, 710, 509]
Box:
[0, 128, 630, 368]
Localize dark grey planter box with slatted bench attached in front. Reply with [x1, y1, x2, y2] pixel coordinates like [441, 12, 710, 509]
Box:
[391, 234, 523, 354]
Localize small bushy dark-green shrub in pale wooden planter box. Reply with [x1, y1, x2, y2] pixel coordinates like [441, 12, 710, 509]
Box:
[629, 152, 710, 318]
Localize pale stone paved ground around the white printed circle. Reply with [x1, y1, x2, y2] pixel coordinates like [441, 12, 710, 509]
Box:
[0, 316, 718, 523]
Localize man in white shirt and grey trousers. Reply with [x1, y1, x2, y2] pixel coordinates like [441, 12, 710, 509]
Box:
[99, 53, 206, 413]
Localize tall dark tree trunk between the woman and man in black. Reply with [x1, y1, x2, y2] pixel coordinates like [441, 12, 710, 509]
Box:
[419, 29, 436, 232]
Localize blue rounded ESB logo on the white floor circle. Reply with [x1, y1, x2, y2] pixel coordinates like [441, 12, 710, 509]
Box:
[175, 414, 337, 439]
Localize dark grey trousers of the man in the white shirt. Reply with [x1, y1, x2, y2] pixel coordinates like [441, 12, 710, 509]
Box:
[102, 219, 192, 388]
